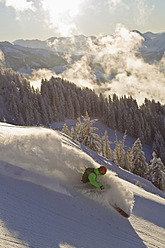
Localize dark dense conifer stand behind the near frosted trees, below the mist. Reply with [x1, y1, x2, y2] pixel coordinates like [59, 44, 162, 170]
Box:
[0, 66, 165, 181]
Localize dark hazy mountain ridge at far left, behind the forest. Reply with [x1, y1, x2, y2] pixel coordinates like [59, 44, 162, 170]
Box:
[0, 42, 68, 74]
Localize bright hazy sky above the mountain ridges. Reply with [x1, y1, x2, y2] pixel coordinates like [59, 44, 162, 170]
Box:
[0, 0, 165, 42]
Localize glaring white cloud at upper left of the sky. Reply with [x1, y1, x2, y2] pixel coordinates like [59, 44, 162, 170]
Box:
[0, 0, 85, 36]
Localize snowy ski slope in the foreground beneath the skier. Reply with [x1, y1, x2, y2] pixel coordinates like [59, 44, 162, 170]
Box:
[0, 123, 165, 248]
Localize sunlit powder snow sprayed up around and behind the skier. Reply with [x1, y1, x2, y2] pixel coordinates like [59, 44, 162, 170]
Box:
[0, 123, 134, 215]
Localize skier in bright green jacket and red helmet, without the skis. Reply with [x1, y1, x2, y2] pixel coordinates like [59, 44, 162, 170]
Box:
[81, 166, 107, 190]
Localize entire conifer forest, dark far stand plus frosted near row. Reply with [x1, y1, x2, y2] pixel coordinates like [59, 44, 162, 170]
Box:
[0, 67, 165, 190]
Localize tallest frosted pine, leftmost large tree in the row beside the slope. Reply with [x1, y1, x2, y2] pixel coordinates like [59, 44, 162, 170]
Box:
[76, 112, 100, 152]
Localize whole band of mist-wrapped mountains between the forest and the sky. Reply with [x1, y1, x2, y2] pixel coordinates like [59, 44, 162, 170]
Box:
[0, 29, 165, 105]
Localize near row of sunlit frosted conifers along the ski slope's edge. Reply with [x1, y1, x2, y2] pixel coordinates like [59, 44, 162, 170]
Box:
[62, 113, 165, 191]
